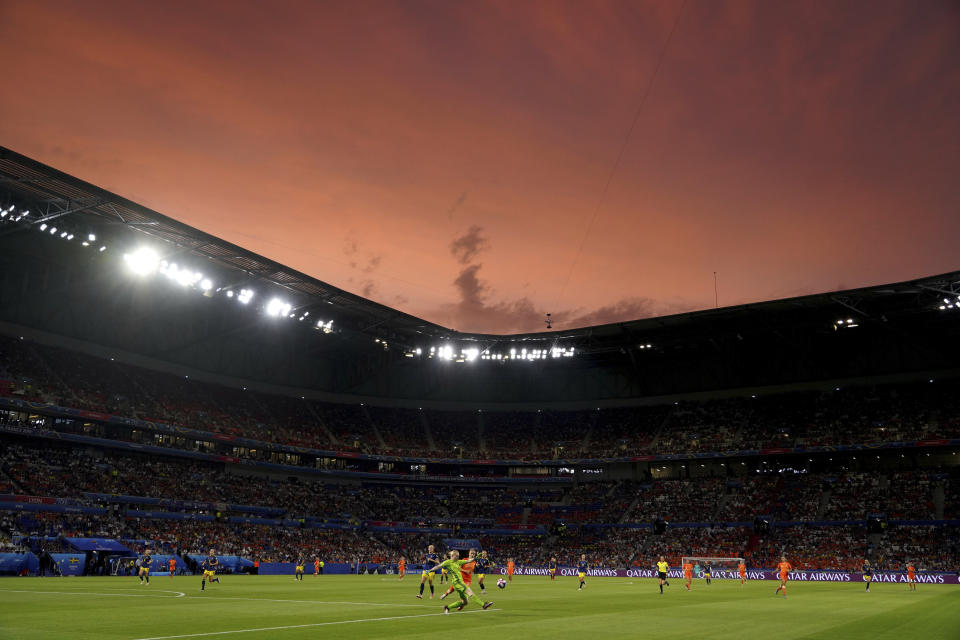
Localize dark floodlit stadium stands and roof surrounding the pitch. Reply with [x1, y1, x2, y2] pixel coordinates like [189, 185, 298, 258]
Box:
[0, 149, 960, 636]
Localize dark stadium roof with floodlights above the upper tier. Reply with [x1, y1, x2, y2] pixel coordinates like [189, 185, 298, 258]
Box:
[0, 147, 960, 401]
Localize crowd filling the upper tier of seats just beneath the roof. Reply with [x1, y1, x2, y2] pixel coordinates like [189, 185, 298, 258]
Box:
[0, 337, 960, 460]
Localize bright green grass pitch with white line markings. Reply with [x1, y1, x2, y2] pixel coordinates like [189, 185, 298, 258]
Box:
[0, 575, 960, 640]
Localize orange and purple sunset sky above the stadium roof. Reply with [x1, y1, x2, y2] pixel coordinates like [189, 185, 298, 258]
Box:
[0, 0, 960, 333]
